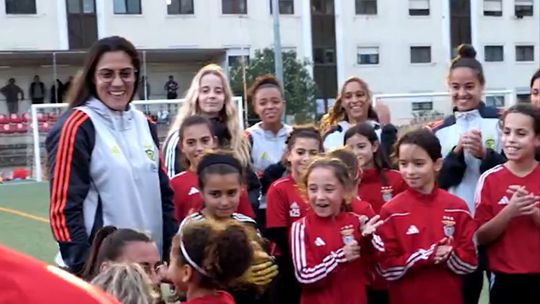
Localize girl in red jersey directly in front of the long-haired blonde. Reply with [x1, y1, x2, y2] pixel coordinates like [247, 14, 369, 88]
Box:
[170, 115, 255, 222]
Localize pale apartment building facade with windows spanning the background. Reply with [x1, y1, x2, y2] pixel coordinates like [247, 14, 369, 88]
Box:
[0, 0, 540, 116]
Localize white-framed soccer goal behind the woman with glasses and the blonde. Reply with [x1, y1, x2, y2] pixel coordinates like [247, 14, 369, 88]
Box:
[0, 97, 244, 181]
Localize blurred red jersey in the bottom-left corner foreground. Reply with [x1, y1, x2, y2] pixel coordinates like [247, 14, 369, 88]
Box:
[0, 246, 119, 304]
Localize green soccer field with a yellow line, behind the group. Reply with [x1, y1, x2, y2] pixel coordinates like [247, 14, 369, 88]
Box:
[0, 182, 488, 304]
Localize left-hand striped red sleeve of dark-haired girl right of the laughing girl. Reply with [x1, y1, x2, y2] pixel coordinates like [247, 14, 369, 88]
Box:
[372, 211, 437, 281]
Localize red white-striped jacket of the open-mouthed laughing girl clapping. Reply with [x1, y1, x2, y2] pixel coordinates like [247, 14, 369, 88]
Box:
[291, 211, 371, 304]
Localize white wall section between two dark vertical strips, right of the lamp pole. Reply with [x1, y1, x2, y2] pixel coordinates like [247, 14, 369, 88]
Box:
[338, 1, 449, 93]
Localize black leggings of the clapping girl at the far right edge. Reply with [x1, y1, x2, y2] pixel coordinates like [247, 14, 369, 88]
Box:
[489, 273, 540, 304]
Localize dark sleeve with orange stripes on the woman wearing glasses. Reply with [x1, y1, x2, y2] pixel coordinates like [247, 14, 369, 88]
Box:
[46, 110, 95, 271]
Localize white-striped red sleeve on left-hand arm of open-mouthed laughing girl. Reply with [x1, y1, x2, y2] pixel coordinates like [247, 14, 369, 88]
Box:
[291, 218, 346, 284]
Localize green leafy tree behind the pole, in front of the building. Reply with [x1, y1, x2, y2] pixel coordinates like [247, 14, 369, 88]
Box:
[230, 48, 317, 123]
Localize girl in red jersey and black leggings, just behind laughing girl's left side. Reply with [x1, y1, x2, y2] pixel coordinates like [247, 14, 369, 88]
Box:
[266, 126, 322, 304]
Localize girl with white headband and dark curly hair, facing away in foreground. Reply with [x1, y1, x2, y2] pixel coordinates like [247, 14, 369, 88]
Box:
[168, 221, 253, 304]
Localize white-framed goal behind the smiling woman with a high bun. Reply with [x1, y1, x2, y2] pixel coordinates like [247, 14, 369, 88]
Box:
[373, 90, 516, 129]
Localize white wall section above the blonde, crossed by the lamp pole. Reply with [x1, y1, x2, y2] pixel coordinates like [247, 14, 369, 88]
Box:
[100, 0, 311, 55]
